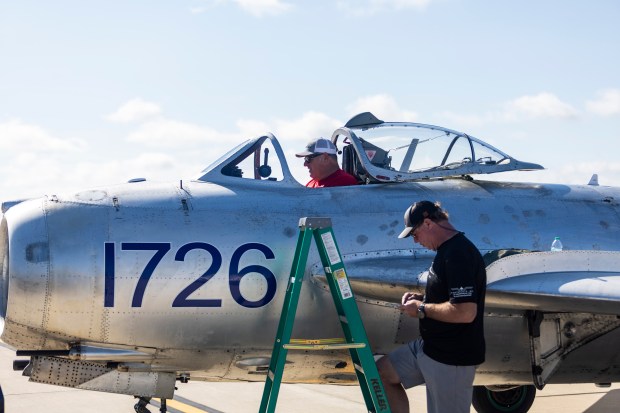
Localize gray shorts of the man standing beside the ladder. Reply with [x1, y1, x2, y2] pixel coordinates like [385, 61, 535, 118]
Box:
[388, 338, 476, 413]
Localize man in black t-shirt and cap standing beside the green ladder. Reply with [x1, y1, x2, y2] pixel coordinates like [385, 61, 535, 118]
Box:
[377, 201, 486, 413]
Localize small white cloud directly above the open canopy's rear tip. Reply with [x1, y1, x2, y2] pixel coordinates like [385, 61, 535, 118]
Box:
[504, 92, 578, 119]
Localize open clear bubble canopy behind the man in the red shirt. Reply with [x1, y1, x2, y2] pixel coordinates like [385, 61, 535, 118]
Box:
[332, 112, 543, 183]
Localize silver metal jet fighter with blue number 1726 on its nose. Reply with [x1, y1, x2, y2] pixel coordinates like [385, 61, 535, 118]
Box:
[0, 113, 620, 412]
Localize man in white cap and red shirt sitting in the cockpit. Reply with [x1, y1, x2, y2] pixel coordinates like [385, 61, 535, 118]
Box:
[295, 138, 358, 188]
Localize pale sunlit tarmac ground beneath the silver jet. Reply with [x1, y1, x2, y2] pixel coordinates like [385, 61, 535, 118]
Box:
[0, 347, 620, 413]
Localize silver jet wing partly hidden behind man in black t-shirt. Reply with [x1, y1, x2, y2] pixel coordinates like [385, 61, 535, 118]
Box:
[312, 250, 620, 315]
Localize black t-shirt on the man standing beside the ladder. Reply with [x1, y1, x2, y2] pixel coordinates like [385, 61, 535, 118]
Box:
[420, 233, 487, 366]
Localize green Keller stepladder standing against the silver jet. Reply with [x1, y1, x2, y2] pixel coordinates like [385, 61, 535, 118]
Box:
[259, 217, 391, 413]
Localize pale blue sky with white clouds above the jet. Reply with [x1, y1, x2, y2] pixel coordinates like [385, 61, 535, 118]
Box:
[0, 0, 620, 201]
